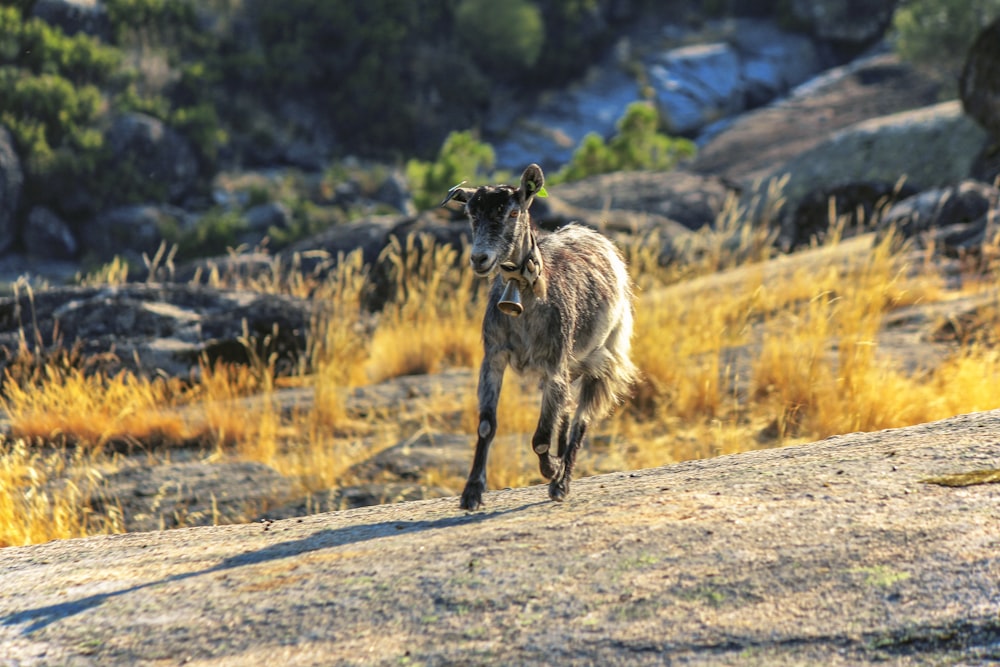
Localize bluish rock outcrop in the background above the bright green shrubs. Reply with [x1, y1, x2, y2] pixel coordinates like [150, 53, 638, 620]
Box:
[486, 19, 824, 169]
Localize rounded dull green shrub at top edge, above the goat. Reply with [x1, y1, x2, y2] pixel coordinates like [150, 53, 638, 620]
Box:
[455, 0, 545, 76]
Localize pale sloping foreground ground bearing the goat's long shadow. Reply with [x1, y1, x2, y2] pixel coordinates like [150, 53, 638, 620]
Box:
[0, 411, 1000, 667]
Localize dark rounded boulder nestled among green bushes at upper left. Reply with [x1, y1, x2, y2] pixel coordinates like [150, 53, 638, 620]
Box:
[107, 113, 198, 202]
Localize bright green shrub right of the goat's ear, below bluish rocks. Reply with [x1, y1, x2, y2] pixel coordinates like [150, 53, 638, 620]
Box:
[551, 102, 696, 183]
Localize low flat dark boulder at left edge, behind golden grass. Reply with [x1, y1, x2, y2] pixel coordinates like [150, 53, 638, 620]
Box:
[0, 283, 313, 378]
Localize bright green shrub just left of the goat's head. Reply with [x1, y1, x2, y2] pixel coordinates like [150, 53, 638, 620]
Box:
[406, 132, 496, 210]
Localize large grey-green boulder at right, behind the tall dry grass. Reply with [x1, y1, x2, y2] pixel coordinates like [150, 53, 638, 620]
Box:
[745, 100, 987, 247]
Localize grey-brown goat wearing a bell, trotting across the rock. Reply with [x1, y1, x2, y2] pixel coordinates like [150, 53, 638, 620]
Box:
[441, 164, 638, 510]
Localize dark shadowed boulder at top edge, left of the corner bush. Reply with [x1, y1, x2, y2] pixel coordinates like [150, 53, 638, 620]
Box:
[788, 0, 899, 56]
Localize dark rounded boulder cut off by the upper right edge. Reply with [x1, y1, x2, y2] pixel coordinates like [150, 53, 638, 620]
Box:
[959, 18, 1000, 141]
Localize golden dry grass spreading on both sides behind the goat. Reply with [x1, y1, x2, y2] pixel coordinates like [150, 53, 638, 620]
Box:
[0, 190, 1000, 545]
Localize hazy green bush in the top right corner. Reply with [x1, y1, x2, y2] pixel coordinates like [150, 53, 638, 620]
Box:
[893, 0, 1000, 81]
